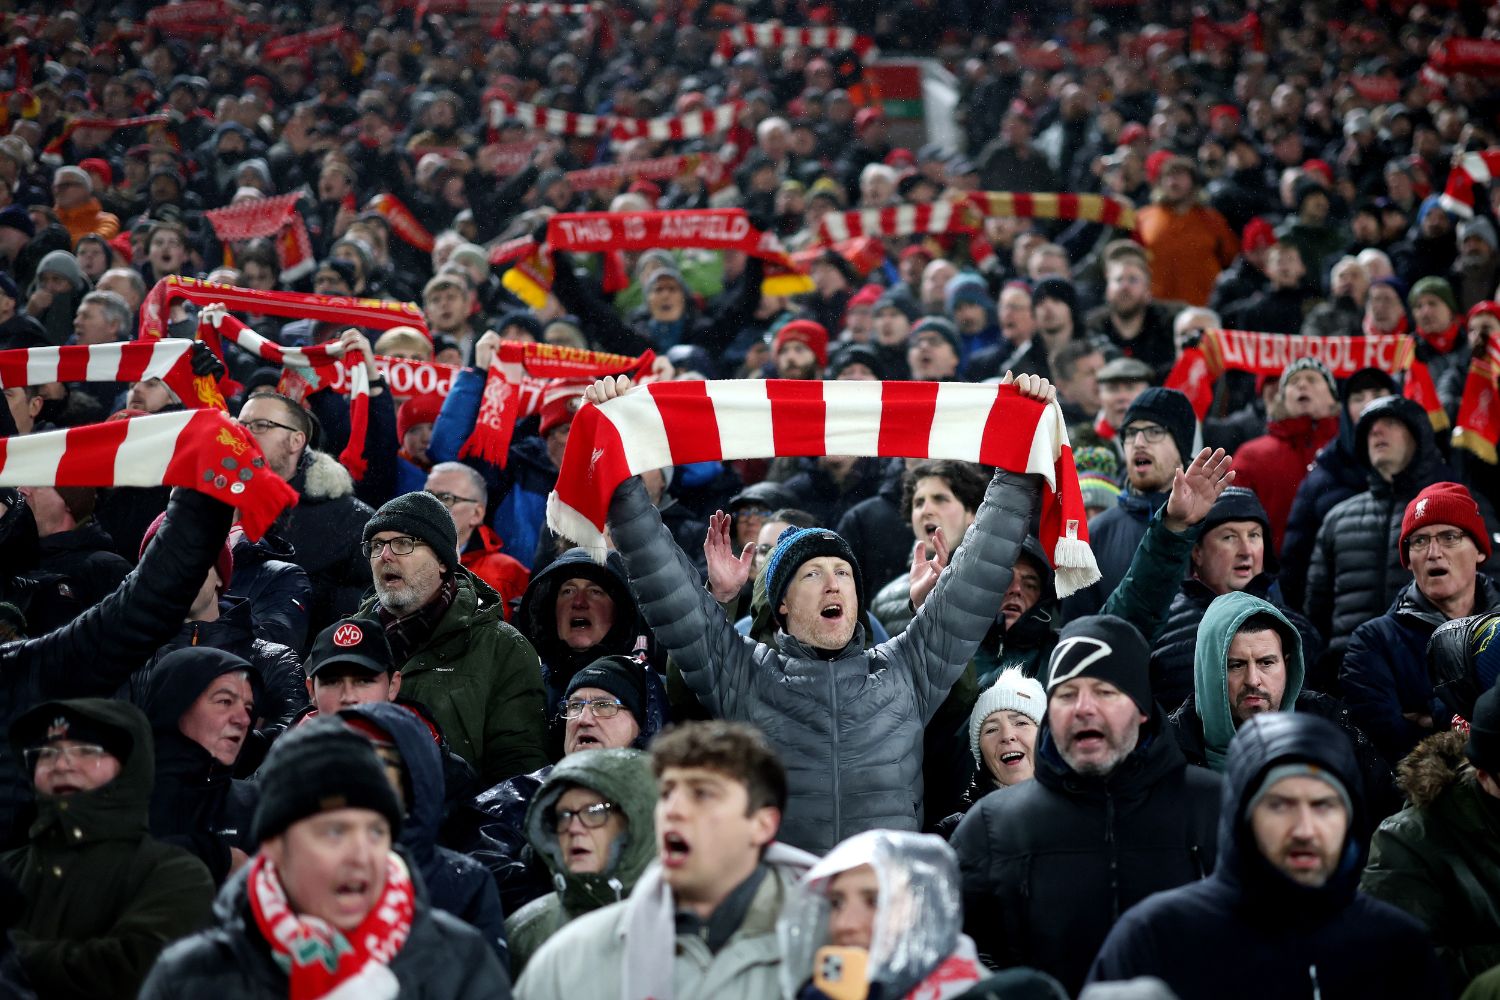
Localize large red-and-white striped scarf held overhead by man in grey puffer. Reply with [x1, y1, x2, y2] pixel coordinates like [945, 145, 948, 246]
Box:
[548, 379, 1100, 597]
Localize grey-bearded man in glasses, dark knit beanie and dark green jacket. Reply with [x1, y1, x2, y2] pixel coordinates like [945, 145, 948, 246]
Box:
[359, 492, 548, 786]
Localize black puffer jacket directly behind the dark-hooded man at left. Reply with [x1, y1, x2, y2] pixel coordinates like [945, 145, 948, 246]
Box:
[131, 597, 308, 778]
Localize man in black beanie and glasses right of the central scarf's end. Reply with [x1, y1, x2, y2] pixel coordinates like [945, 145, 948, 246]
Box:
[1062, 387, 1197, 619]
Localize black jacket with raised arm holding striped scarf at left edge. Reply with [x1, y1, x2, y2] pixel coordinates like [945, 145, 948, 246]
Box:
[0, 490, 233, 846]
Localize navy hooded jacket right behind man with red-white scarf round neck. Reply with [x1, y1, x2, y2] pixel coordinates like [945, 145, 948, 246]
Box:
[339, 702, 507, 963]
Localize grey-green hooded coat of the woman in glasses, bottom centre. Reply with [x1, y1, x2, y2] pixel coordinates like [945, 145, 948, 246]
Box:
[506, 750, 656, 978]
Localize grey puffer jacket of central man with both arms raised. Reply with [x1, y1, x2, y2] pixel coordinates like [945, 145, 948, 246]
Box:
[609, 472, 1040, 853]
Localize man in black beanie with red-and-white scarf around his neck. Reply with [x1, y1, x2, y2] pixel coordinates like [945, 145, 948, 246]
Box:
[141, 720, 510, 1000]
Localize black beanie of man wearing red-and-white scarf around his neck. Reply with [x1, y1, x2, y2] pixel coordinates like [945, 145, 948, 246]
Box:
[252, 718, 402, 841]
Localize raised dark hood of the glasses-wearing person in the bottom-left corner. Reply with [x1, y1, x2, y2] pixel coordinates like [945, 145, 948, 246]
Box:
[11, 699, 156, 847]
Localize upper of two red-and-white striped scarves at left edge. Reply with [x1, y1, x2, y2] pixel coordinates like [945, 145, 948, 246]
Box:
[0, 340, 224, 409]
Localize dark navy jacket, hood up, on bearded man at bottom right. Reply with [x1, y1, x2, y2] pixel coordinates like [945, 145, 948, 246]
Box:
[1089, 712, 1449, 1000]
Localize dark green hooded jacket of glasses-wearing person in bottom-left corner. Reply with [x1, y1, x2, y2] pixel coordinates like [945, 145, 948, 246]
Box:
[0, 699, 213, 999]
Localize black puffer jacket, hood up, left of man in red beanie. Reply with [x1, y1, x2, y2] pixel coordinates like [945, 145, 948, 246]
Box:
[1305, 396, 1484, 668]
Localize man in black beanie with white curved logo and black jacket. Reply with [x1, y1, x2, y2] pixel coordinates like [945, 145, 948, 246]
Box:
[951, 615, 1220, 996]
